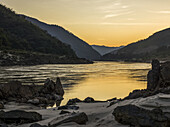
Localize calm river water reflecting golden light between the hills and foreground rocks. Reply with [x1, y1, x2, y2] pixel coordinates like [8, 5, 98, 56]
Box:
[0, 62, 151, 104]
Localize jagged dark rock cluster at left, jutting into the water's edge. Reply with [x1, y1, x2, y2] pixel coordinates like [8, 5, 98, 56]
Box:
[0, 78, 64, 107]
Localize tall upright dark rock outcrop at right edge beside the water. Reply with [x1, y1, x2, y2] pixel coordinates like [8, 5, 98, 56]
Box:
[124, 60, 170, 99]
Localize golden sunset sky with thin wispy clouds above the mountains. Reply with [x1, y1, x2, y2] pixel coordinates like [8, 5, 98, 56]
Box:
[0, 0, 170, 46]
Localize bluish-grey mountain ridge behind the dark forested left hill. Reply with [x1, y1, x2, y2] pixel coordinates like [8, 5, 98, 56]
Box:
[25, 16, 101, 60]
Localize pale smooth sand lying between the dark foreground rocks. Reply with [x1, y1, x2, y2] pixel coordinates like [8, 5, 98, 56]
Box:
[1, 94, 170, 127]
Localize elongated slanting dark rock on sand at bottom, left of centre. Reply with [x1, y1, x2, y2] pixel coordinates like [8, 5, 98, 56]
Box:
[48, 112, 88, 127]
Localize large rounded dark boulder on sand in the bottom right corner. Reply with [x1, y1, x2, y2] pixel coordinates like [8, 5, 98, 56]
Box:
[113, 105, 170, 127]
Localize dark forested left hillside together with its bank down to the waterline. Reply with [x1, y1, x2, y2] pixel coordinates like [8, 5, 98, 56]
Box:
[0, 4, 91, 65]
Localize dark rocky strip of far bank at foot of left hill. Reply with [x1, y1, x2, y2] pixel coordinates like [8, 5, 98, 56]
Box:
[0, 50, 93, 66]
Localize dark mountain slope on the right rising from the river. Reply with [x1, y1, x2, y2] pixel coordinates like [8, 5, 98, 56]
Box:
[102, 28, 170, 61]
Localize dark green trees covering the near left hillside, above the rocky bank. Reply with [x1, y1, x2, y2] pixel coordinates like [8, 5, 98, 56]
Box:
[0, 5, 76, 57]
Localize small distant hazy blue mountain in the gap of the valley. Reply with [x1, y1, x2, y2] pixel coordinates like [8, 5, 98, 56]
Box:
[91, 45, 124, 56]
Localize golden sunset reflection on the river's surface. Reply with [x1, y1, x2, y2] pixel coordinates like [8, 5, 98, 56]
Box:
[62, 62, 150, 104]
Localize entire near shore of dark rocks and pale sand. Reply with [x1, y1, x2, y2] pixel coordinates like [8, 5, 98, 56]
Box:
[0, 60, 170, 127]
